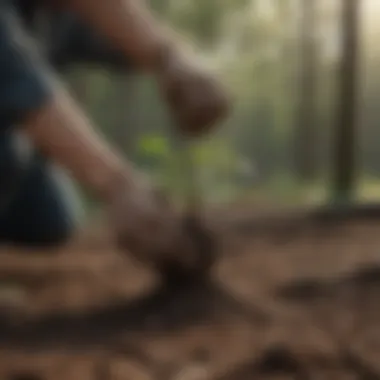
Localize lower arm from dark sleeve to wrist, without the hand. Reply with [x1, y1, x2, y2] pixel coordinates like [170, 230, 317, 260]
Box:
[0, 2, 132, 201]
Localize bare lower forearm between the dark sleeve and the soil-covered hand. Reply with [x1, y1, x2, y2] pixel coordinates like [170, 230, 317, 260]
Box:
[23, 83, 132, 201]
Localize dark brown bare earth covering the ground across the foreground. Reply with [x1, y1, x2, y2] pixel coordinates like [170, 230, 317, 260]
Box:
[0, 208, 380, 380]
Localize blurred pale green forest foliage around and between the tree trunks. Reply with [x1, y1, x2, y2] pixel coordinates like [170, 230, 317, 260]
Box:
[63, 0, 380, 208]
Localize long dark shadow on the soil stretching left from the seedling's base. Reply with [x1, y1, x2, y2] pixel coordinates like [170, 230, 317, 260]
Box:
[0, 280, 268, 349]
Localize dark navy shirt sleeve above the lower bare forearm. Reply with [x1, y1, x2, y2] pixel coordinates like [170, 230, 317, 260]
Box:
[0, 2, 52, 127]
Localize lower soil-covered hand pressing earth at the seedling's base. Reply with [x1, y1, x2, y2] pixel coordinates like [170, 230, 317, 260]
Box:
[108, 176, 186, 267]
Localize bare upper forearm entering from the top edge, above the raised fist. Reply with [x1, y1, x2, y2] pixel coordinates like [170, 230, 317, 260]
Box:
[60, 0, 173, 71]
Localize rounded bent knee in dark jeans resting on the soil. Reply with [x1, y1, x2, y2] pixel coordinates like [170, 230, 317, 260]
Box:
[0, 166, 83, 248]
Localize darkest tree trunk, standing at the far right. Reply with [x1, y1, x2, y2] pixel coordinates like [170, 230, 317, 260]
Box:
[332, 0, 360, 203]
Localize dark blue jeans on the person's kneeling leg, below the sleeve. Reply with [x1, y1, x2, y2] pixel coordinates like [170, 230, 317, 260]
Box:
[0, 132, 78, 247]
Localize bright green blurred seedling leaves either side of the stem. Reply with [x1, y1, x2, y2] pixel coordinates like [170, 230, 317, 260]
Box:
[136, 133, 255, 201]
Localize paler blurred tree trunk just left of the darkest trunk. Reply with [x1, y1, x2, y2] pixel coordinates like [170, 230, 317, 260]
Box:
[294, 0, 318, 181]
